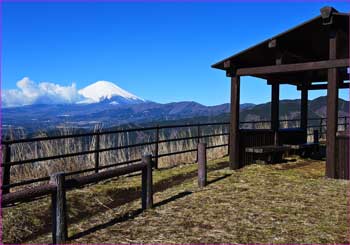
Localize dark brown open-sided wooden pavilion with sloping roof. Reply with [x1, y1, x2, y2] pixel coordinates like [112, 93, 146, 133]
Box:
[212, 7, 350, 179]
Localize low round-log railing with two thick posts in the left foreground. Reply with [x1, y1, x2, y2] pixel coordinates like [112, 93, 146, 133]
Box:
[1, 155, 154, 244]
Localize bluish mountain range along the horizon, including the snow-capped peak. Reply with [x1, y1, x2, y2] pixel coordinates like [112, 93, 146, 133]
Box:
[2, 81, 349, 132]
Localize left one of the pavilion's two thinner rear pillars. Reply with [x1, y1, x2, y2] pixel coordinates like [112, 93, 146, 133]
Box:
[271, 82, 280, 145]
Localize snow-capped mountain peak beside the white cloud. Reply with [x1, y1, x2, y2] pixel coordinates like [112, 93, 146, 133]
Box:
[78, 81, 145, 105]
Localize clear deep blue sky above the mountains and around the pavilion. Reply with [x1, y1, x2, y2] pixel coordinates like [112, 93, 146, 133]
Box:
[1, 2, 350, 105]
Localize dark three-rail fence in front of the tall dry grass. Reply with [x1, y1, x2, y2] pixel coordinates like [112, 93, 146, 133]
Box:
[1, 117, 349, 194]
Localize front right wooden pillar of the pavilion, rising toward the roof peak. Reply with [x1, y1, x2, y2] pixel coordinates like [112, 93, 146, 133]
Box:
[326, 31, 339, 178]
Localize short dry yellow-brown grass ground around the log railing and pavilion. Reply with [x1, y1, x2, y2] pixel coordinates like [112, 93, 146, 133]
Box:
[4, 156, 349, 243]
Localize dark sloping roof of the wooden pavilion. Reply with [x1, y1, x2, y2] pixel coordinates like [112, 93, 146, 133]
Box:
[212, 7, 350, 84]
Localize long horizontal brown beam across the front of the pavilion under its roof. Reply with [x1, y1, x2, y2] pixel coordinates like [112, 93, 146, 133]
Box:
[236, 59, 350, 76]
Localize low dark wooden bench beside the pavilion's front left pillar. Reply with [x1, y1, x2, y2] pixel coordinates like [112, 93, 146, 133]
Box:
[245, 145, 290, 163]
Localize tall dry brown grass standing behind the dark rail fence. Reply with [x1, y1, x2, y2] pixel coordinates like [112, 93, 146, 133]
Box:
[6, 127, 228, 191]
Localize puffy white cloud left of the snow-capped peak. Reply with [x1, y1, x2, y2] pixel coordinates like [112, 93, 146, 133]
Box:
[2, 77, 82, 107]
